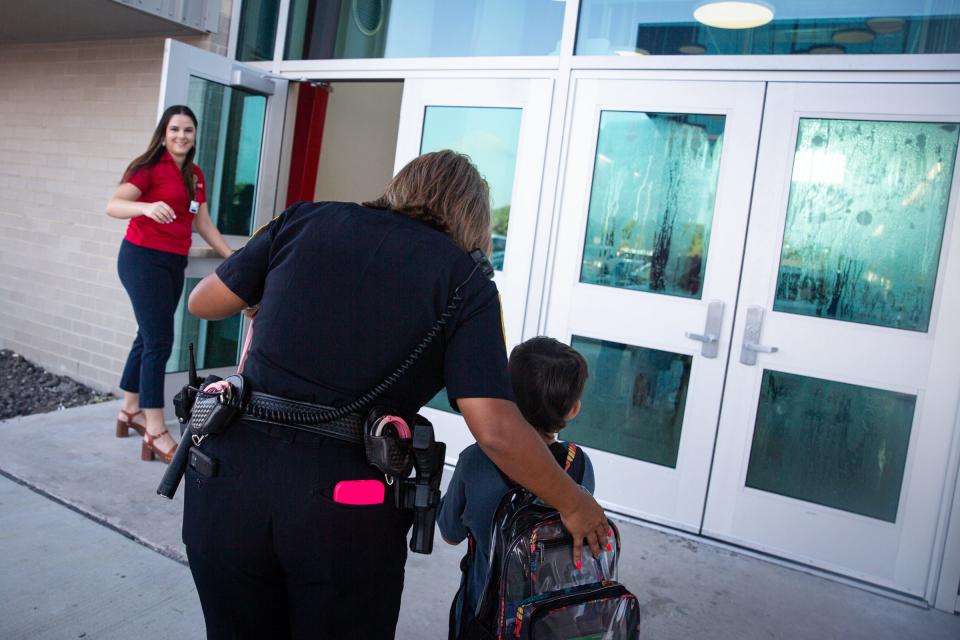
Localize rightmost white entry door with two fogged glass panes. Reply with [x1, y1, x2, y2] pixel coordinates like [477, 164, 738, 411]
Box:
[704, 83, 960, 596]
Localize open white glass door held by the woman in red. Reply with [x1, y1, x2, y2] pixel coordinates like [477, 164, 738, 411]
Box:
[157, 39, 287, 410]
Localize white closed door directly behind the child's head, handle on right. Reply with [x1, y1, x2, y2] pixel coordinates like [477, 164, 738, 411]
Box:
[546, 79, 764, 531]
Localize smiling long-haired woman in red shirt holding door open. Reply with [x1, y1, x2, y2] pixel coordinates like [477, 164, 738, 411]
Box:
[107, 105, 232, 463]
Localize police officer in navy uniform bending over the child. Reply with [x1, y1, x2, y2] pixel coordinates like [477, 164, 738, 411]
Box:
[183, 151, 608, 640]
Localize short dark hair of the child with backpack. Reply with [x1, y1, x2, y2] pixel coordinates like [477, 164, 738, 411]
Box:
[510, 336, 587, 433]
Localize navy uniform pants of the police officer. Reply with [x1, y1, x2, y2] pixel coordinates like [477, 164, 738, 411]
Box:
[183, 419, 411, 640]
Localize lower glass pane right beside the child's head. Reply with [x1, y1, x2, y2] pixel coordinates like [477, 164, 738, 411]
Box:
[562, 336, 692, 468]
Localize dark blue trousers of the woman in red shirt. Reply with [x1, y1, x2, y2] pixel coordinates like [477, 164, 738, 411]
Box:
[117, 240, 187, 409]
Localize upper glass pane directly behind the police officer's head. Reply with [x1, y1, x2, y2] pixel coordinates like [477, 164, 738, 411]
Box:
[420, 107, 523, 271]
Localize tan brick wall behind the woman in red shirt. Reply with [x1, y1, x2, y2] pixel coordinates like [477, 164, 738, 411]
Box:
[0, 0, 231, 390]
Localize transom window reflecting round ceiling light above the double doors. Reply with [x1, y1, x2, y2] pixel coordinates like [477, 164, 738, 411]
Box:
[576, 0, 960, 56]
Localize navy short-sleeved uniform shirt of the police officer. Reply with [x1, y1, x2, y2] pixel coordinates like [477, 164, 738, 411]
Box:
[217, 202, 513, 411]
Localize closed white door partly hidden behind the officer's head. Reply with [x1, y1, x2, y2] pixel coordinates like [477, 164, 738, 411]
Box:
[394, 78, 553, 462]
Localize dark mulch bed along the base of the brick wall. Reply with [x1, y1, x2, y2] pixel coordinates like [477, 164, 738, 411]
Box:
[0, 349, 113, 420]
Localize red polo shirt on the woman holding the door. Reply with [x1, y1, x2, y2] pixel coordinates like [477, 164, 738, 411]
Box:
[125, 151, 207, 256]
